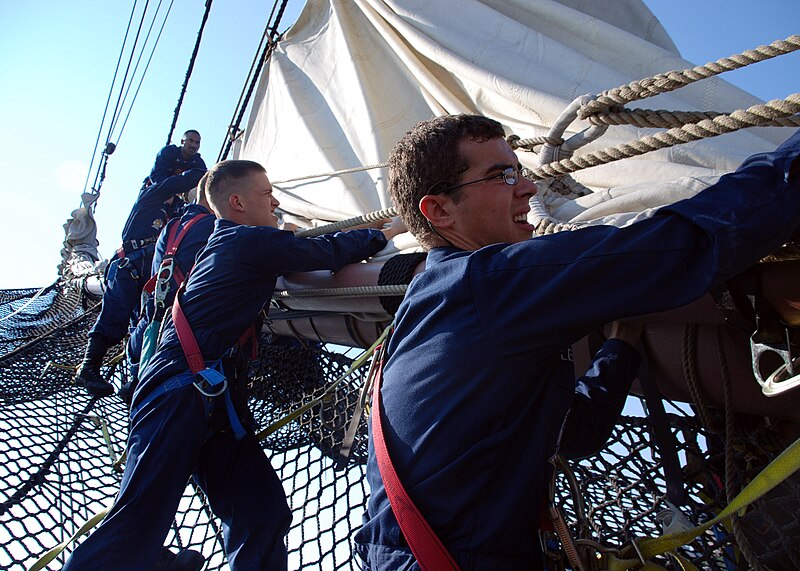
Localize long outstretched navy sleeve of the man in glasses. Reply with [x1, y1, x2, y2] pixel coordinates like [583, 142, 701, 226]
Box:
[470, 133, 800, 355]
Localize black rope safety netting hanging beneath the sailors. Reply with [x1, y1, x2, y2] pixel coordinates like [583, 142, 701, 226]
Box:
[0, 284, 800, 571]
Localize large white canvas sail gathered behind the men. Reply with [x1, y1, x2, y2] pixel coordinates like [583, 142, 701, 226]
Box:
[237, 0, 788, 238]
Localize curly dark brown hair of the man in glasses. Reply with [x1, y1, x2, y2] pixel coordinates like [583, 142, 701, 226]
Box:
[389, 115, 505, 249]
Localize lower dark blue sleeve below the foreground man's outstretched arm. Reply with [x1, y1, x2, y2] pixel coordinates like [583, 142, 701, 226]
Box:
[559, 339, 642, 459]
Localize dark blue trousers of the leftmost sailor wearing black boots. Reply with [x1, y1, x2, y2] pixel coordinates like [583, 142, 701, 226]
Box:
[89, 244, 155, 344]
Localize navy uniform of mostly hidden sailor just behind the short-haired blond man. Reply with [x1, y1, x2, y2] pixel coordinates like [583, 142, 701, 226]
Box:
[126, 204, 215, 374]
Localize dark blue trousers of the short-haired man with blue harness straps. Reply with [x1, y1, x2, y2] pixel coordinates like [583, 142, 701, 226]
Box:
[63, 378, 291, 571]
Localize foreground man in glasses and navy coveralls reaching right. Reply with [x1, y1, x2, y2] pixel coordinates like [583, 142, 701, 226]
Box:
[354, 115, 800, 571]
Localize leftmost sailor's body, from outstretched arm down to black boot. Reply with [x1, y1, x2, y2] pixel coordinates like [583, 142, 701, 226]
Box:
[75, 169, 205, 397]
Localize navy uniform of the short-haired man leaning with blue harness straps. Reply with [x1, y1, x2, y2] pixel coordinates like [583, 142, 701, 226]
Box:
[64, 220, 386, 571]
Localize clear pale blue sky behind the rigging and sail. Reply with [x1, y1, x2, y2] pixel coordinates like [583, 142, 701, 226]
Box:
[0, 0, 800, 289]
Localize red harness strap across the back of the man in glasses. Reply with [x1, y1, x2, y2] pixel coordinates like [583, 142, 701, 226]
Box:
[372, 350, 459, 571]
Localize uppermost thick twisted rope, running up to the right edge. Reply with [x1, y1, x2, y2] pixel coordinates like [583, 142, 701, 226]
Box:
[578, 35, 800, 119]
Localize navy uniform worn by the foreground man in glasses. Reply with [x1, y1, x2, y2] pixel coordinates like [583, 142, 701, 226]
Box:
[355, 134, 800, 571]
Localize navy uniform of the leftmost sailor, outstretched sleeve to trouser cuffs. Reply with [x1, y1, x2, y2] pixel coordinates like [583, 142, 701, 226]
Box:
[89, 170, 204, 346]
